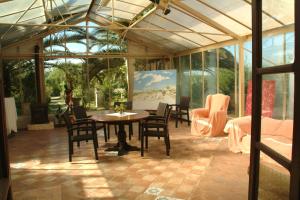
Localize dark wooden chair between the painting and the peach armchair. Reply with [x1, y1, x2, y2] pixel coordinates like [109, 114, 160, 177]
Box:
[171, 96, 190, 128]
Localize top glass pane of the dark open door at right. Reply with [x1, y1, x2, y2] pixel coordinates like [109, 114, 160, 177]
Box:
[262, 0, 295, 67]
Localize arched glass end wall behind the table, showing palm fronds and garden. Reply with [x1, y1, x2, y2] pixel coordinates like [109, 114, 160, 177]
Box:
[44, 22, 128, 109]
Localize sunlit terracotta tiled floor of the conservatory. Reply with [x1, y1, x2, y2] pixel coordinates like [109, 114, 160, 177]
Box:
[9, 123, 249, 200]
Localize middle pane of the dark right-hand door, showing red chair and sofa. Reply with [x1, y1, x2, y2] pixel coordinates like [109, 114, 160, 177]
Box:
[261, 74, 294, 159]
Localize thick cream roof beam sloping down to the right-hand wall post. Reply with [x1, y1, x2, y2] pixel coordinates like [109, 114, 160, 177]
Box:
[172, 0, 241, 39]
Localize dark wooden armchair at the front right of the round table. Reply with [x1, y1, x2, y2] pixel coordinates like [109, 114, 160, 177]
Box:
[141, 103, 172, 156]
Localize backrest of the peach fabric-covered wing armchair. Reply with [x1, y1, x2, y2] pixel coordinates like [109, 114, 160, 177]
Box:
[205, 94, 230, 115]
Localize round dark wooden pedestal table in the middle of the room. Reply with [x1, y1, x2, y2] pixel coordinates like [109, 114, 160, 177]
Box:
[91, 110, 149, 156]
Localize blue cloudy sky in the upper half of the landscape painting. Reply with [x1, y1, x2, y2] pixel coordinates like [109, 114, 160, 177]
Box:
[134, 70, 176, 92]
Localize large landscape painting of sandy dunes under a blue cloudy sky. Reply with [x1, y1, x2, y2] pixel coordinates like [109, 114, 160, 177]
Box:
[133, 70, 176, 110]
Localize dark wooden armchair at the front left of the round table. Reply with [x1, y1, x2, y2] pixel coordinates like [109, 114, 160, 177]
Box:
[63, 112, 98, 162]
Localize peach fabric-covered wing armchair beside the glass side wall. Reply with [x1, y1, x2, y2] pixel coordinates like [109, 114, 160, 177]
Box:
[191, 94, 230, 136]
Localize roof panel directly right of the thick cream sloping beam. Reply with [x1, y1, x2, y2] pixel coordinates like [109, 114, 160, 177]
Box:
[183, 0, 251, 36]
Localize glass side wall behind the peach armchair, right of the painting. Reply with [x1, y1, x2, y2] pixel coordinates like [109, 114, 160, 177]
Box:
[173, 45, 239, 116]
